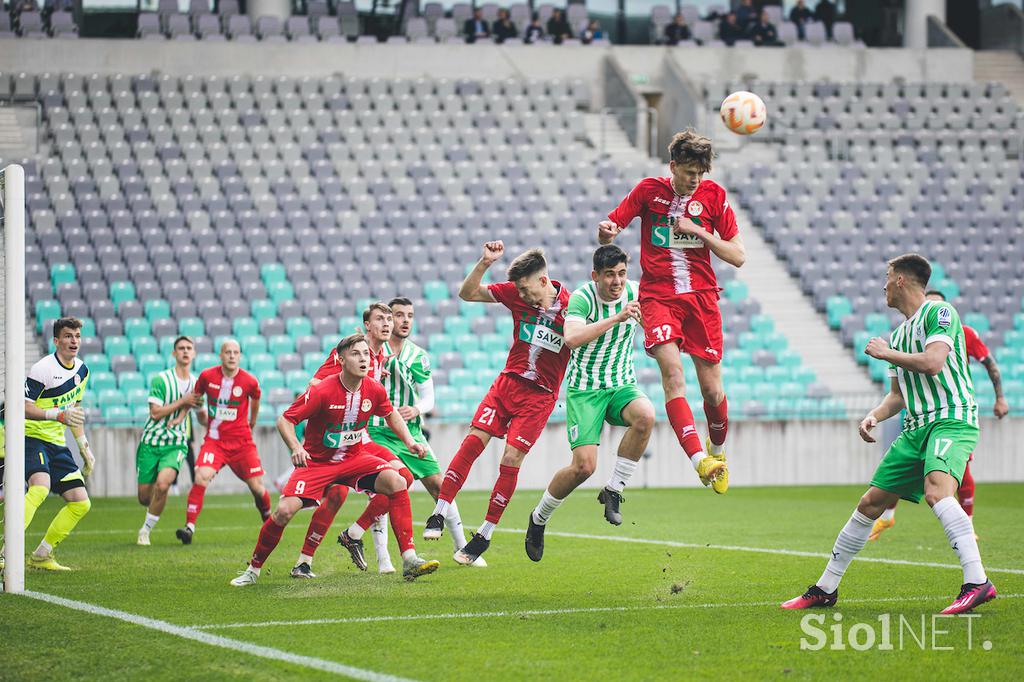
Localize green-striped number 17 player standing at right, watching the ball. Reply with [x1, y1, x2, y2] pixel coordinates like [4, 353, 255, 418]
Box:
[782, 254, 995, 614]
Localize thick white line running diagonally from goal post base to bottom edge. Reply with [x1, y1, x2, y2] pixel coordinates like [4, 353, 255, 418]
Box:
[20, 591, 412, 682]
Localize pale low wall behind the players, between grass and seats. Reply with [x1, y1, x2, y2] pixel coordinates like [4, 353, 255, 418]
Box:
[72, 419, 1024, 496]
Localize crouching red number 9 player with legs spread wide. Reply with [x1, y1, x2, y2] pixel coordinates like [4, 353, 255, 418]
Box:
[231, 334, 440, 587]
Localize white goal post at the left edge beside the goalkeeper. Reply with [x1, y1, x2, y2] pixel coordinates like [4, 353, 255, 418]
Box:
[0, 166, 27, 592]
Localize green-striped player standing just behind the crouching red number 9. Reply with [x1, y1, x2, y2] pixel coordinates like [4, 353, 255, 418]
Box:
[367, 297, 487, 567]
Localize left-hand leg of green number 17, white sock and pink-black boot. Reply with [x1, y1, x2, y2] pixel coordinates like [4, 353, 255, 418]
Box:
[781, 485, 898, 609]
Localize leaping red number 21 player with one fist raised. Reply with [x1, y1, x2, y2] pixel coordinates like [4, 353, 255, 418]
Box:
[423, 242, 570, 565]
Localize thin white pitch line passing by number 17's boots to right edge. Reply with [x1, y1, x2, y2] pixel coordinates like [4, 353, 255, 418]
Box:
[191, 594, 1024, 630]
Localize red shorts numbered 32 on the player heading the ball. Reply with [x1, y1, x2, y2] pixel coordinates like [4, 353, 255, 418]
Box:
[640, 291, 722, 364]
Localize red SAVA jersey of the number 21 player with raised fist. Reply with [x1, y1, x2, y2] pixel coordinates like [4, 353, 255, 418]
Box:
[487, 280, 571, 393]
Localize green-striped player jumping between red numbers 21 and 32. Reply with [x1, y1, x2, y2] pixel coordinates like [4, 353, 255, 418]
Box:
[526, 244, 654, 561]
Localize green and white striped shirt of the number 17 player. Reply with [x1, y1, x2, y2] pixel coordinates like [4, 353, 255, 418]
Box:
[889, 301, 978, 430]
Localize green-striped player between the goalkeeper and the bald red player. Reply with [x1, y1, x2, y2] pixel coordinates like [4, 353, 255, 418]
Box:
[135, 336, 206, 546]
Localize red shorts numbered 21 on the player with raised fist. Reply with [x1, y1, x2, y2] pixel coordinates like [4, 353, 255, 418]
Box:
[472, 374, 558, 453]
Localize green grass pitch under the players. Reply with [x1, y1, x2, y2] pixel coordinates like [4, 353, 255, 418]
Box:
[0, 484, 1024, 681]
